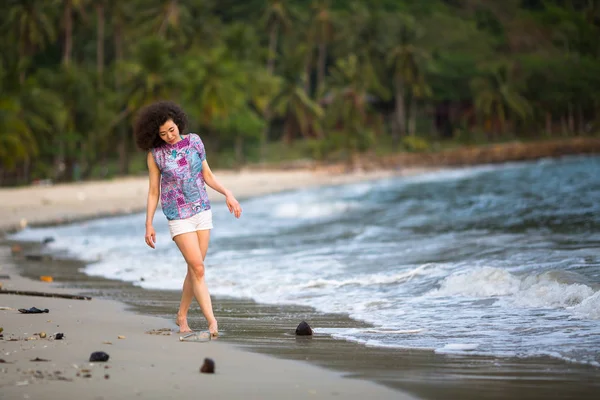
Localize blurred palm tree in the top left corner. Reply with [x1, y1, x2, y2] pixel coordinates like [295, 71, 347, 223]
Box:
[2, 0, 56, 84]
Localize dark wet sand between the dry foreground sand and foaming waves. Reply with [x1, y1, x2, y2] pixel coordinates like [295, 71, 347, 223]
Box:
[5, 239, 600, 399]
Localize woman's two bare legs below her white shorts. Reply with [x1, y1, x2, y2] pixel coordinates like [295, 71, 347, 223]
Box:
[174, 231, 218, 336]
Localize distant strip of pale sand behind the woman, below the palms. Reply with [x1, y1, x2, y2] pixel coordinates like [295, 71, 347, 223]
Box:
[0, 168, 426, 233]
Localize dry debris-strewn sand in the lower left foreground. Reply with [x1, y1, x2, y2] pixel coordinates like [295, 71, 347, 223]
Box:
[0, 246, 414, 399]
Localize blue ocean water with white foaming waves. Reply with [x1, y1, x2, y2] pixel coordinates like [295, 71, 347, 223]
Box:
[13, 157, 600, 367]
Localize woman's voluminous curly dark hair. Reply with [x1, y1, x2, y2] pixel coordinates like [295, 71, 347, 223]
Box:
[133, 101, 188, 151]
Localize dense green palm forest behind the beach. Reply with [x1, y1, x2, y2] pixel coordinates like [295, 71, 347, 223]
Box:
[0, 0, 600, 184]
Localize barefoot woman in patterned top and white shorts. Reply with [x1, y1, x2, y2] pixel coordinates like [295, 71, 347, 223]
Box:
[134, 101, 242, 336]
